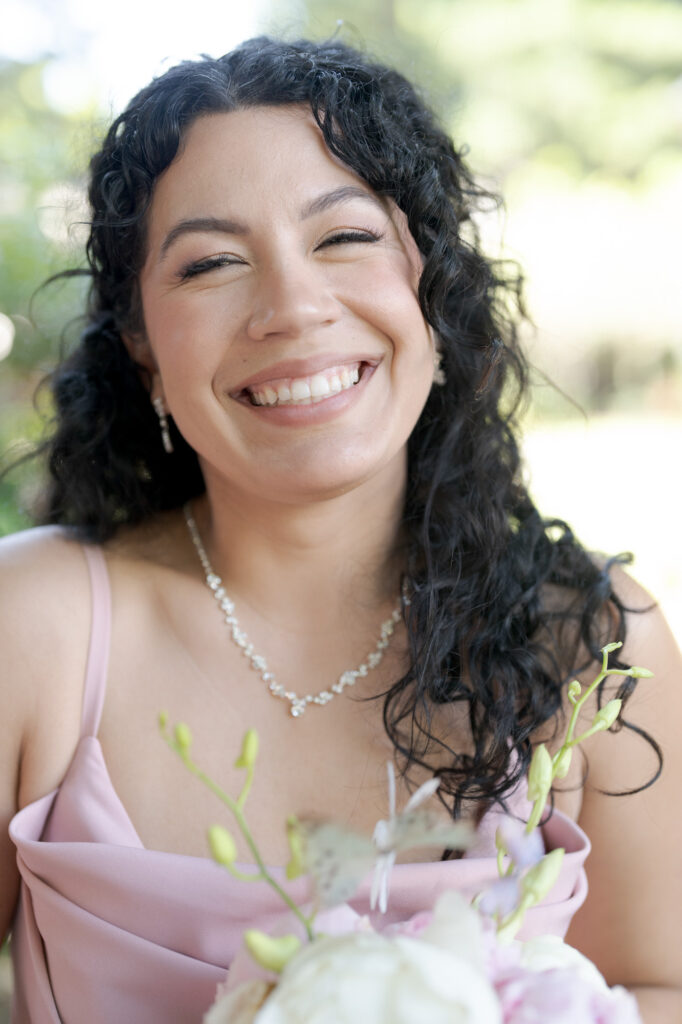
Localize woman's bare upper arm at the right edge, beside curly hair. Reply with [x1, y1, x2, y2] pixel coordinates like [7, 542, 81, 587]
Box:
[567, 573, 682, 987]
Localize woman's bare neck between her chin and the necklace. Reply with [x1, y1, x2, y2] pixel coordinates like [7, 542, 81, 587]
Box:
[188, 460, 404, 629]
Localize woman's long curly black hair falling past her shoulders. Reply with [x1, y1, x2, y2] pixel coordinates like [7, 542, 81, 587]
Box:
[31, 37, 655, 815]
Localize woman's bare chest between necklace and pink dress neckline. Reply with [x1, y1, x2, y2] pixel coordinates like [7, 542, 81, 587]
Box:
[89, 561, 578, 864]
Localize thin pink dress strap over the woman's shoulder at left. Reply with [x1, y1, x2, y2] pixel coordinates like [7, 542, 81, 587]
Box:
[81, 545, 112, 737]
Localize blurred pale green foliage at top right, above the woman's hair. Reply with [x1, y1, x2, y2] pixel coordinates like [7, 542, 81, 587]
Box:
[290, 0, 682, 178]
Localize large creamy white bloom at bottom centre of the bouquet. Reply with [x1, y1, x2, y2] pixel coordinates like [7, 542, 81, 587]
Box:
[245, 932, 502, 1024]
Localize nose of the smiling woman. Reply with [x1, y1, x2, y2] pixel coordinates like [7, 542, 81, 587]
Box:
[247, 259, 341, 341]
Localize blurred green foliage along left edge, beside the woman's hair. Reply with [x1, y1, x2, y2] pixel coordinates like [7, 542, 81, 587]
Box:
[0, 55, 92, 532]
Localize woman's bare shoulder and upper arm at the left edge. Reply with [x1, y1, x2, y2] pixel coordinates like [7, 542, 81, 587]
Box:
[0, 528, 89, 941]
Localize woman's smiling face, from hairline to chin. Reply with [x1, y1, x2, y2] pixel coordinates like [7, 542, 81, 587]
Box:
[134, 108, 433, 502]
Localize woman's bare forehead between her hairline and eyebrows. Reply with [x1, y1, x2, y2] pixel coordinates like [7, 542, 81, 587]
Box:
[150, 106, 372, 233]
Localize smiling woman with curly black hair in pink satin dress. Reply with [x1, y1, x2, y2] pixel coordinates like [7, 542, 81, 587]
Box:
[0, 39, 682, 1024]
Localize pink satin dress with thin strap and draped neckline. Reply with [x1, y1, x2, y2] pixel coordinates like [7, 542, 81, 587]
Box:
[9, 548, 590, 1024]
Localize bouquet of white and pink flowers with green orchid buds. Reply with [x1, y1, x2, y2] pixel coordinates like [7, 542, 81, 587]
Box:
[161, 644, 651, 1024]
